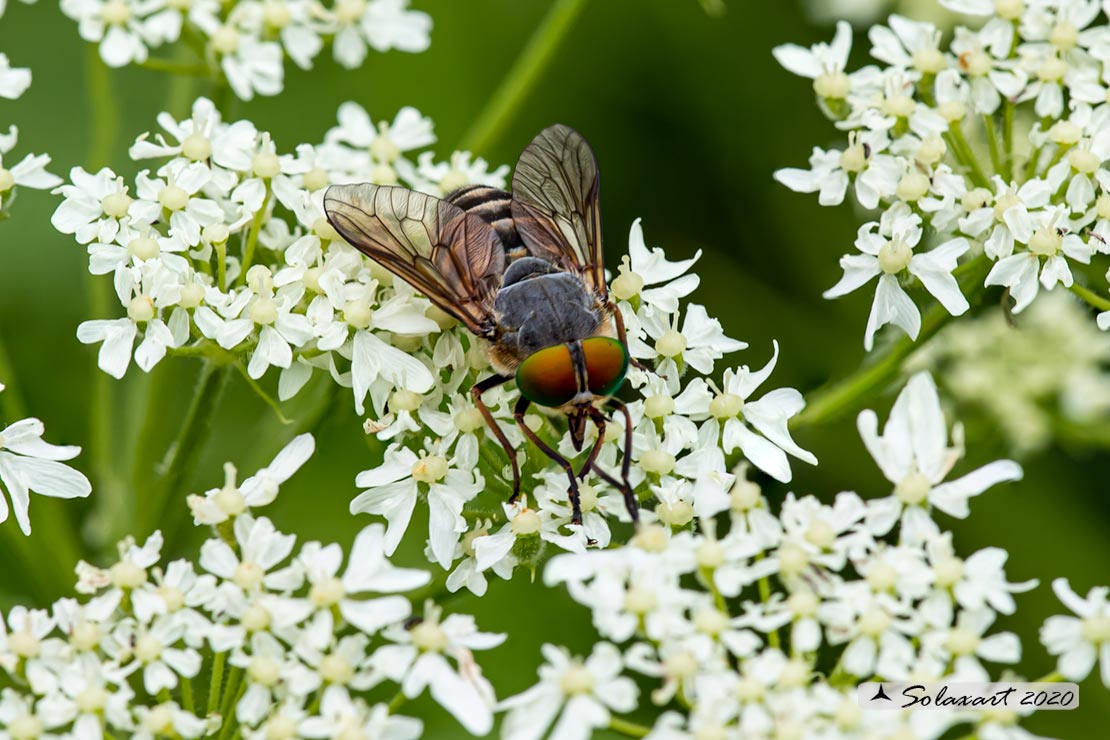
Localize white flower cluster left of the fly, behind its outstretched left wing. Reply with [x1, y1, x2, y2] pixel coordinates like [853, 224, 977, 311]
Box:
[53, 98, 506, 408]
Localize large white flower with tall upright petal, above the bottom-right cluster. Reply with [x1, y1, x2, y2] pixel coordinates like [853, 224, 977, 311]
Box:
[857, 373, 1021, 543]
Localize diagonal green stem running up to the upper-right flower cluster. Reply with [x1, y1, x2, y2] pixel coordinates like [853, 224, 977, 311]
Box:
[790, 255, 990, 429]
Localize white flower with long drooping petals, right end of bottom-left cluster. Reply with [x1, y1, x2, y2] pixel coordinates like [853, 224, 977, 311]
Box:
[371, 602, 506, 736]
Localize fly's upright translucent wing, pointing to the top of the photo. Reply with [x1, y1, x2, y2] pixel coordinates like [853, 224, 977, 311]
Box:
[513, 124, 608, 298]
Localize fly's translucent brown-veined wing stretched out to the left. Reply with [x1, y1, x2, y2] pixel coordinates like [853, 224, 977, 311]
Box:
[324, 184, 505, 336]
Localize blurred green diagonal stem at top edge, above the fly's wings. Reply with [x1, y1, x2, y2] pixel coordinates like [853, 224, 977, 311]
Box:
[462, 0, 586, 153]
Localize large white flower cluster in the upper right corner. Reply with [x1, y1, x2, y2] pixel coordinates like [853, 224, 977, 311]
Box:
[775, 0, 1110, 349]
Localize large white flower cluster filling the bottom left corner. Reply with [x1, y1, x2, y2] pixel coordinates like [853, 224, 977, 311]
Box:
[0, 435, 504, 740]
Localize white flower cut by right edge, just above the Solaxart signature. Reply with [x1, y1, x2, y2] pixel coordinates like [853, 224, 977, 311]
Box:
[1040, 578, 1110, 688]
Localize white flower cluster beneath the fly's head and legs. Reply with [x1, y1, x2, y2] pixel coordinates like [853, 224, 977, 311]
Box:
[351, 215, 817, 595]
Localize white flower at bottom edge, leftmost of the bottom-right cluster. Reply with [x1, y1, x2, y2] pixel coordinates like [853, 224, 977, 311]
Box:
[498, 642, 639, 740]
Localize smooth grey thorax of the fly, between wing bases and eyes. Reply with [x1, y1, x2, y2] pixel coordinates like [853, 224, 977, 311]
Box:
[494, 271, 602, 357]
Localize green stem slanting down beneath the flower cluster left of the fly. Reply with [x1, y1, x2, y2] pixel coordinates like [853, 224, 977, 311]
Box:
[139, 363, 228, 539]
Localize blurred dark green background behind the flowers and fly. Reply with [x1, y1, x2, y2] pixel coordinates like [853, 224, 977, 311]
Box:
[0, 0, 1110, 739]
